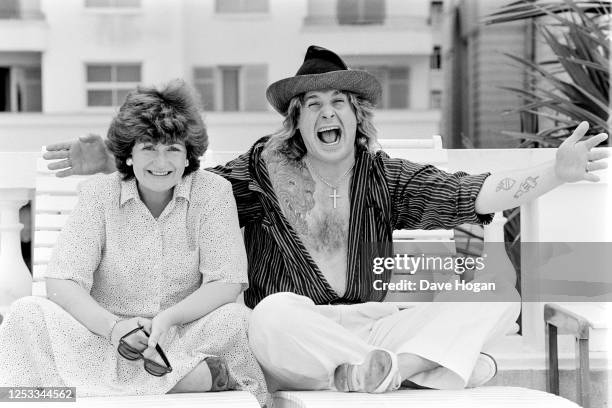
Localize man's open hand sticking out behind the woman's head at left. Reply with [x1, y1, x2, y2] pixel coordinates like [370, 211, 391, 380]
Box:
[43, 134, 115, 177]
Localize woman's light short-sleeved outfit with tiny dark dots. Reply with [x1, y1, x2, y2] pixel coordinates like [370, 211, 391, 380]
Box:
[0, 170, 269, 404]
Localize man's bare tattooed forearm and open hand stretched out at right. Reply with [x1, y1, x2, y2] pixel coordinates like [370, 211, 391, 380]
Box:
[476, 122, 609, 214]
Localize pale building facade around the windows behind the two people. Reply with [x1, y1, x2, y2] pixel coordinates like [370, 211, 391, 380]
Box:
[0, 0, 440, 151]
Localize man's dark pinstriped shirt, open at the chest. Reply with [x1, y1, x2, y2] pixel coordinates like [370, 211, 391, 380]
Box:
[210, 137, 493, 307]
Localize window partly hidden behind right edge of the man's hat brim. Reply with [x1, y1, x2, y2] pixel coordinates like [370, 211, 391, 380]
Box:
[354, 65, 410, 109]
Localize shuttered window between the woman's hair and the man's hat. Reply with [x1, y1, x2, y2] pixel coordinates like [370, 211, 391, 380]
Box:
[193, 65, 268, 112]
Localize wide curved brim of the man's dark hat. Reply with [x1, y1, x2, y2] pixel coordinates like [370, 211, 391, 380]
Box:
[266, 70, 382, 116]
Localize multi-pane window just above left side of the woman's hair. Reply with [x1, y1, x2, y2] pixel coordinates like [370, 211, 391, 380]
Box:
[86, 64, 141, 107]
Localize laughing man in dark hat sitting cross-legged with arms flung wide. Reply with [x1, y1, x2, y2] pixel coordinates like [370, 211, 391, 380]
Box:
[45, 46, 607, 392]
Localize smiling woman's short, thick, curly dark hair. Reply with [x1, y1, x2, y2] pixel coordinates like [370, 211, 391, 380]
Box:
[106, 79, 208, 180]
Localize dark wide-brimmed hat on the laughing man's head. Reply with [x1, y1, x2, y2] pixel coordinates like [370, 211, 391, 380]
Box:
[266, 45, 382, 116]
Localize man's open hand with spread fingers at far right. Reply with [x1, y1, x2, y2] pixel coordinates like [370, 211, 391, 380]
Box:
[555, 122, 610, 183]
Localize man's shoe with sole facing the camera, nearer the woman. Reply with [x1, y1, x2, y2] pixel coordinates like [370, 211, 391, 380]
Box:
[334, 349, 401, 393]
